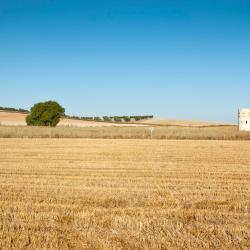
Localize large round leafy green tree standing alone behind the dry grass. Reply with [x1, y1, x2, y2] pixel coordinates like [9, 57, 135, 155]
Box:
[26, 101, 65, 127]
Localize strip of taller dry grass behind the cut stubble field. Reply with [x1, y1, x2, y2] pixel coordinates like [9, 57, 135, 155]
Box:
[0, 126, 250, 140]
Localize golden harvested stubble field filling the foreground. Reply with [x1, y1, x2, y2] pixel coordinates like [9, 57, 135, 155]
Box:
[0, 139, 250, 249]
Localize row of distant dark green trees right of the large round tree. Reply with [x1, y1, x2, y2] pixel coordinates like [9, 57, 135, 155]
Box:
[65, 115, 154, 122]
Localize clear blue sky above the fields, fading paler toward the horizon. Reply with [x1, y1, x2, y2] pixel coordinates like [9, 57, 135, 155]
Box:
[0, 0, 250, 122]
